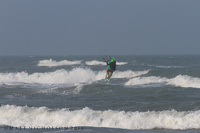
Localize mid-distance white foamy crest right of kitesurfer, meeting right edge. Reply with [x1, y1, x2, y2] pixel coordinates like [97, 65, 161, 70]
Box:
[125, 75, 200, 88]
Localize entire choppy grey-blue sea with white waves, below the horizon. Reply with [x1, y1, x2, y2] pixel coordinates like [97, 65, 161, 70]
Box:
[0, 55, 200, 133]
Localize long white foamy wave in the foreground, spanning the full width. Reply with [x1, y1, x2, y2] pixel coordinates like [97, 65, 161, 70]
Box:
[0, 105, 200, 130]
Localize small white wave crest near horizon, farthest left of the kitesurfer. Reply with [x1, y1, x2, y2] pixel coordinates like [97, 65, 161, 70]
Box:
[38, 59, 81, 67]
